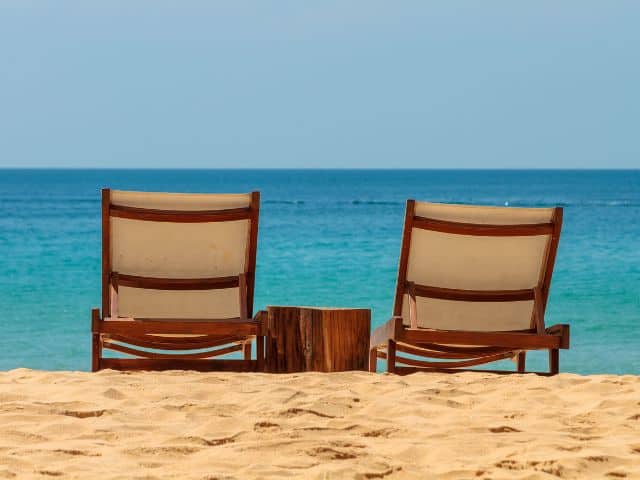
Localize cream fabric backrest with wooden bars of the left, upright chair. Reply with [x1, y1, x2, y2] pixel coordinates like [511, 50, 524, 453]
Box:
[102, 189, 260, 319]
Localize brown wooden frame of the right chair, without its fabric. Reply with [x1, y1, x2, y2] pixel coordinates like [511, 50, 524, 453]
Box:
[369, 200, 569, 375]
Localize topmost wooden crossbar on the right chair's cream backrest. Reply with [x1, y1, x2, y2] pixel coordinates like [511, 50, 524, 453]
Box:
[413, 216, 554, 237]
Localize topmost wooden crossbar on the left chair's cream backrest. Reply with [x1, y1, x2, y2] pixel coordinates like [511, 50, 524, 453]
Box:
[110, 205, 252, 223]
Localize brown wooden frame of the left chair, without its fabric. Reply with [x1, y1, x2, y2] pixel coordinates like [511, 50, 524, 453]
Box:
[91, 189, 264, 372]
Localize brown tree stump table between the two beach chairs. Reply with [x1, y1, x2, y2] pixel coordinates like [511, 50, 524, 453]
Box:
[264, 306, 371, 373]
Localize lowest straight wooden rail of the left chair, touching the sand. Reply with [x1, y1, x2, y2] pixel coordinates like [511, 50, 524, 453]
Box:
[101, 358, 256, 372]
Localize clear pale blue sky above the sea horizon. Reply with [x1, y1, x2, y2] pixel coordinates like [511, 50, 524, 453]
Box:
[0, 0, 640, 168]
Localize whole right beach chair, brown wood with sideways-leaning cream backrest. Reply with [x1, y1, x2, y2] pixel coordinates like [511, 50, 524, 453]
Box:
[369, 200, 569, 375]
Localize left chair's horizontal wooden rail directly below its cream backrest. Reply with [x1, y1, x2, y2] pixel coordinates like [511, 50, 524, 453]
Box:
[96, 318, 259, 336]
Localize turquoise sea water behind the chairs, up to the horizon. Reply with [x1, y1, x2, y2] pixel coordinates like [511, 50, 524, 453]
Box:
[0, 170, 640, 374]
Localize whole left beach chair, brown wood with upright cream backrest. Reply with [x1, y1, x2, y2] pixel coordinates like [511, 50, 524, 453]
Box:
[92, 189, 264, 371]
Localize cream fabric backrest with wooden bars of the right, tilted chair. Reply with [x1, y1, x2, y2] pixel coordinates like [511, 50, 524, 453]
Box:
[394, 200, 562, 331]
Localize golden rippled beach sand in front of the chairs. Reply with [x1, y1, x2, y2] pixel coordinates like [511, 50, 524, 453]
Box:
[0, 369, 640, 480]
